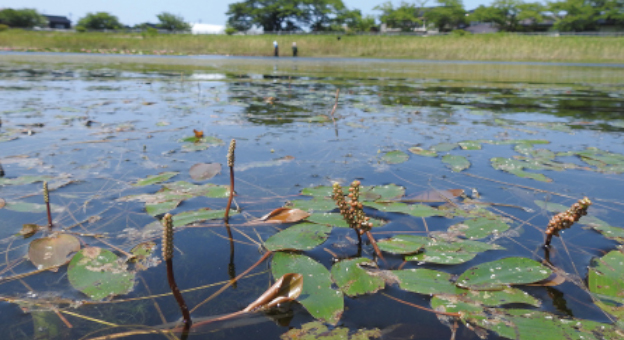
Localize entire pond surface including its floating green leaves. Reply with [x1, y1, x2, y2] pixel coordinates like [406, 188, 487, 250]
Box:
[0, 54, 624, 339]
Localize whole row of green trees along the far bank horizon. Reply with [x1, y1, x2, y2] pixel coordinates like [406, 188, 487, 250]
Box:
[0, 0, 624, 34]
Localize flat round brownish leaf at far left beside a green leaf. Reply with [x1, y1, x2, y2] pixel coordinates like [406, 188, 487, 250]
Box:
[28, 234, 80, 269]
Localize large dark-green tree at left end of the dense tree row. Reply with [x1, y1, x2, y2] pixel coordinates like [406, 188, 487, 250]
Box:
[226, 0, 308, 32]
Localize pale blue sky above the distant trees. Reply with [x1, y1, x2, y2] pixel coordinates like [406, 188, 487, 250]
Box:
[6, 0, 491, 26]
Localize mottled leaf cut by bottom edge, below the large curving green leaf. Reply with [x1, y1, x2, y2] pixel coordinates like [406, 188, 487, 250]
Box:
[282, 318, 382, 340]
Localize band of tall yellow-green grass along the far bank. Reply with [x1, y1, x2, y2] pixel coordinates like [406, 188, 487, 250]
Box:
[0, 30, 624, 64]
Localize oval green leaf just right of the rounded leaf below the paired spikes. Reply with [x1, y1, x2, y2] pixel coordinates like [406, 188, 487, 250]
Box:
[390, 269, 464, 295]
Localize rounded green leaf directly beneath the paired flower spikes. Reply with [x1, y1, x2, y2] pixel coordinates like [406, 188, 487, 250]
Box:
[331, 258, 385, 296]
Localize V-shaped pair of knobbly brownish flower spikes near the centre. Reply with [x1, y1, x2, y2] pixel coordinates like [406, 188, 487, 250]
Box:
[332, 181, 373, 231]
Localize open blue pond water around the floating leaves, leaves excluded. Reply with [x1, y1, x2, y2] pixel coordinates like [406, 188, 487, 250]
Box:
[0, 55, 624, 339]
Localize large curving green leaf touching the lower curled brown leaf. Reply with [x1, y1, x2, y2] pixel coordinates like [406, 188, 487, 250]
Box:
[271, 252, 344, 325]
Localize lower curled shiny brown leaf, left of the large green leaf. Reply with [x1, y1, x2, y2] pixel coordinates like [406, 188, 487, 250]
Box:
[243, 273, 303, 312]
